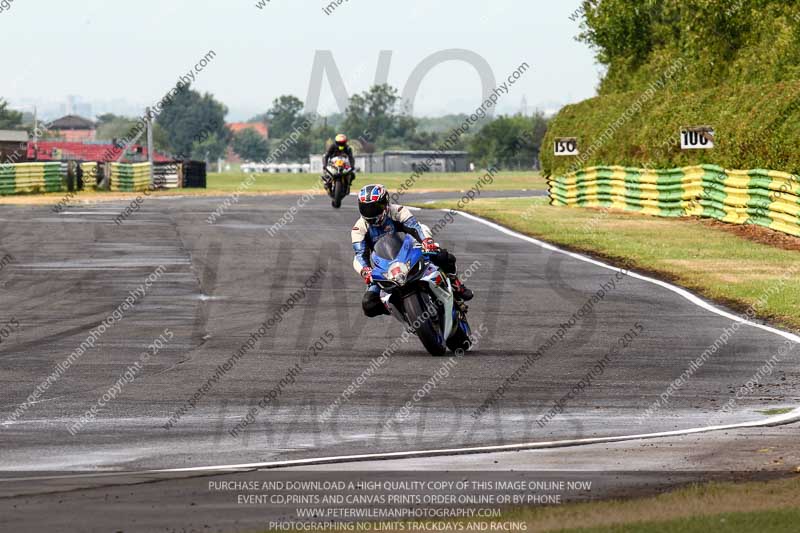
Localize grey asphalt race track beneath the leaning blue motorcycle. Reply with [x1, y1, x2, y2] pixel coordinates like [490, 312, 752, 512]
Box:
[0, 190, 800, 528]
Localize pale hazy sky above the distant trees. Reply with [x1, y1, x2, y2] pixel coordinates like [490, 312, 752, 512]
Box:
[0, 0, 600, 120]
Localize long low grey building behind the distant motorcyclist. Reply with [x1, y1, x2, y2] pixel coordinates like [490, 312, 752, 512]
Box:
[311, 150, 469, 174]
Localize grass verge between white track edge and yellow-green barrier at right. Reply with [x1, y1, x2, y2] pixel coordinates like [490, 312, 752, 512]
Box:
[412, 199, 800, 329]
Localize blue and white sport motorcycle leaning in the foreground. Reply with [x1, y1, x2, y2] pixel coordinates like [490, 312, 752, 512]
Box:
[370, 233, 472, 356]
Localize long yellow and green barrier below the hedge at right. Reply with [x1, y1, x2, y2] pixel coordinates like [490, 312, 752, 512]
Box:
[548, 165, 800, 237]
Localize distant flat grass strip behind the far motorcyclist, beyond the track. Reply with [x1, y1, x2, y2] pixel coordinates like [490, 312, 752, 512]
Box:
[207, 172, 547, 193]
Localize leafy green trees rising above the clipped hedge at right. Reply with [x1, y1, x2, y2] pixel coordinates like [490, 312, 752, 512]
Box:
[578, 0, 800, 95]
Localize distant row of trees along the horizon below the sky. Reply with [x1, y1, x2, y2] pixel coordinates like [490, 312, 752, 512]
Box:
[0, 85, 547, 169]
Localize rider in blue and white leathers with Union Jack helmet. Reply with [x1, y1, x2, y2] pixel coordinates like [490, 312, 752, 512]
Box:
[351, 185, 473, 318]
